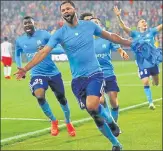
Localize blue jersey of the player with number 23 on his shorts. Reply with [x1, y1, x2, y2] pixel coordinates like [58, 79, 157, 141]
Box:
[15, 30, 60, 76]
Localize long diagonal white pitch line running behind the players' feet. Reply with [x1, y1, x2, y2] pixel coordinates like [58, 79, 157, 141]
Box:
[1, 98, 162, 143]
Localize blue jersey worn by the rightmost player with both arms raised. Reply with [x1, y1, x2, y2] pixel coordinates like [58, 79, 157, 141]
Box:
[130, 28, 158, 68]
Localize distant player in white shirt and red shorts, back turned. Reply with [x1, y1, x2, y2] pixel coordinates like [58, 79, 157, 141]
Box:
[1, 37, 12, 79]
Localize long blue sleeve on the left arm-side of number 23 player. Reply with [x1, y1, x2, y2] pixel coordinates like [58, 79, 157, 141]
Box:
[15, 40, 23, 67]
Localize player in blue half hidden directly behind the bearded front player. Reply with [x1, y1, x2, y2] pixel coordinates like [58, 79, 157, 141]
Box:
[80, 12, 129, 122]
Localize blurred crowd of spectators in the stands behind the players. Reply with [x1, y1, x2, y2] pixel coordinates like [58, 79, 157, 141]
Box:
[1, 0, 163, 46]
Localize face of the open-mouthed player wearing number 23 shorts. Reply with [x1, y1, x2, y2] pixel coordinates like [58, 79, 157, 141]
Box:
[23, 19, 34, 35]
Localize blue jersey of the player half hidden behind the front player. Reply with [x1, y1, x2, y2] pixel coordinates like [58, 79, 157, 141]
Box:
[94, 38, 120, 78]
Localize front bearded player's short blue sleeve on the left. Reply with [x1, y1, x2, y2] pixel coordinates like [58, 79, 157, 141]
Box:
[46, 29, 62, 49]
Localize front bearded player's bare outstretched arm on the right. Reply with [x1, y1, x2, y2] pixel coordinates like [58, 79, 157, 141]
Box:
[100, 30, 131, 47]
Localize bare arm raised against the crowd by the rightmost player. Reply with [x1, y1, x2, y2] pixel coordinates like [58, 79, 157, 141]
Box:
[113, 6, 131, 35]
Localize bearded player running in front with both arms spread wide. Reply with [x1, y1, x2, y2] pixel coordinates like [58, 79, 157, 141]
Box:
[15, 1, 135, 150]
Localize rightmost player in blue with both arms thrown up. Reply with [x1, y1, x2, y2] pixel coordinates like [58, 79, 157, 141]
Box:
[114, 6, 162, 109]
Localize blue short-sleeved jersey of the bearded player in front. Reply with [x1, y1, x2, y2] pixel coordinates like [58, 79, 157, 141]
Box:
[47, 20, 102, 78]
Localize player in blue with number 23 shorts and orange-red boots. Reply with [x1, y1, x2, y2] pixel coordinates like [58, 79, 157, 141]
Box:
[15, 16, 76, 136]
